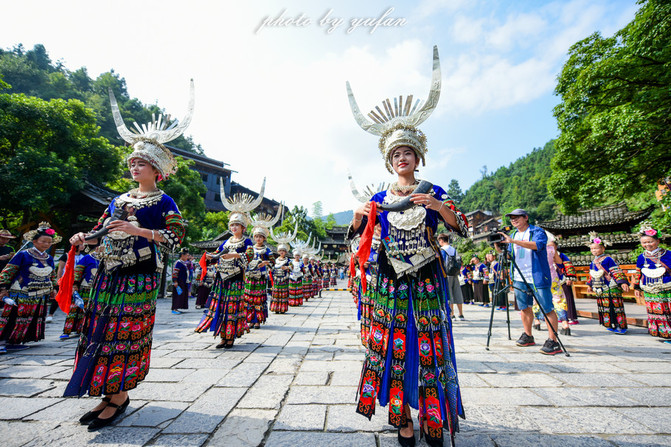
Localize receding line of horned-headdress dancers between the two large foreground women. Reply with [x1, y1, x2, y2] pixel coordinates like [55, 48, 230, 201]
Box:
[195, 199, 336, 348]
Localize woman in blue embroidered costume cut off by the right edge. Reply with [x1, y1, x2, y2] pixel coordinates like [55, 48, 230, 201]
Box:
[634, 224, 671, 344]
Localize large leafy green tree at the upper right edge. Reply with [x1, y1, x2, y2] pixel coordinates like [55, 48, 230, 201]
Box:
[549, 0, 671, 213]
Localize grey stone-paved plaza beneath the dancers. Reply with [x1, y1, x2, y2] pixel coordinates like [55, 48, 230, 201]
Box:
[0, 291, 671, 447]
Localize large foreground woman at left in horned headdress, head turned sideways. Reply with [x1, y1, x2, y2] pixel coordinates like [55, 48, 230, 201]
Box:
[64, 81, 194, 430]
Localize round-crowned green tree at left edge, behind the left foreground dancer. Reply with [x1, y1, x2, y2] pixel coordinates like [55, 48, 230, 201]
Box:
[0, 93, 121, 226]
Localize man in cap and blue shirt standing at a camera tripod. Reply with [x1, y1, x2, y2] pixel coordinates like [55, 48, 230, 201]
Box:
[500, 208, 562, 355]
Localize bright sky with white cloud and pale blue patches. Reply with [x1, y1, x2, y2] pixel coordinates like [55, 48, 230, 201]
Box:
[0, 0, 638, 214]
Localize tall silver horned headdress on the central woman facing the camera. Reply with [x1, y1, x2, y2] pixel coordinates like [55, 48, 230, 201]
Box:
[347, 46, 441, 174]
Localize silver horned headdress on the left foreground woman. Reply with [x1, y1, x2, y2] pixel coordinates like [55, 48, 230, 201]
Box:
[109, 79, 195, 180]
